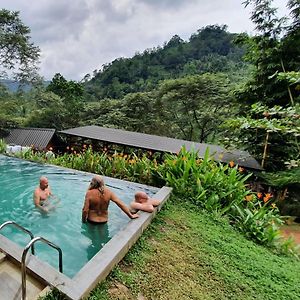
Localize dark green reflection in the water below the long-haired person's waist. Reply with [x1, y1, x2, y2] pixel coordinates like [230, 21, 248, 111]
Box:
[81, 223, 111, 260]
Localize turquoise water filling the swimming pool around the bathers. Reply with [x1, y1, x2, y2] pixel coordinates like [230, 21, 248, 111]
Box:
[0, 155, 156, 277]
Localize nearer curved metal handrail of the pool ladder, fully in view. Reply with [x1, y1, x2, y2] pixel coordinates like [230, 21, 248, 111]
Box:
[21, 236, 63, 300]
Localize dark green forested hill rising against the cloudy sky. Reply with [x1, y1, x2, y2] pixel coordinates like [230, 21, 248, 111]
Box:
[84, 25, 247, 101]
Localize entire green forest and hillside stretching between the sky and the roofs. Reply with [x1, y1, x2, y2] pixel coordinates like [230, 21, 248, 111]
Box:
[0, 0, 300, 175]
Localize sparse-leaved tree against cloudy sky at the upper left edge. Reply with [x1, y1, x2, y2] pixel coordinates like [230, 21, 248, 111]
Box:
[0, 9, 40, 82]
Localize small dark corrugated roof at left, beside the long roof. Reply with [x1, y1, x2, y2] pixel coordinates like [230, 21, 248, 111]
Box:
[5, 128, 55, 149]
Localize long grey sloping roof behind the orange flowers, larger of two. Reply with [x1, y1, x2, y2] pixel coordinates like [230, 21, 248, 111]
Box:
[59, 126, 263, 170]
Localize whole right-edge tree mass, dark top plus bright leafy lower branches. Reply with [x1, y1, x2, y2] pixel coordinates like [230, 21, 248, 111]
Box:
[225, 0, 300, 171]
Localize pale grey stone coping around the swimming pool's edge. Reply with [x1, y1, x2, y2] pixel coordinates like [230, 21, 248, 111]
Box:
[0, 184, 172, 300]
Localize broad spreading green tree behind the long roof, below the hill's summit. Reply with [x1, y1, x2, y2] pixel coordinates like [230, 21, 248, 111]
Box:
[157, 74, 234, 143]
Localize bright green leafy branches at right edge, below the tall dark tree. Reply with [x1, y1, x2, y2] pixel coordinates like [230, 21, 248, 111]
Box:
[224, 102, 300, 170]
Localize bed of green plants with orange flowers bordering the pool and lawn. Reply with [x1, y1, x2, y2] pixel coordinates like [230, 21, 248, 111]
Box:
[8, 147, 298, 256]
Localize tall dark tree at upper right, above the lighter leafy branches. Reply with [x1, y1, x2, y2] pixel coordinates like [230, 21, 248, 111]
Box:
[236, 0, 300, 106]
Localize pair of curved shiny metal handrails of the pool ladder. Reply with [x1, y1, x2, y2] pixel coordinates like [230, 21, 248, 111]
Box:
[0, 221, 63, 300]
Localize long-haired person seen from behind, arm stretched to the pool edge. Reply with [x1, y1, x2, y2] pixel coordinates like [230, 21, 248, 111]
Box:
[82, 175, 139, 224]
